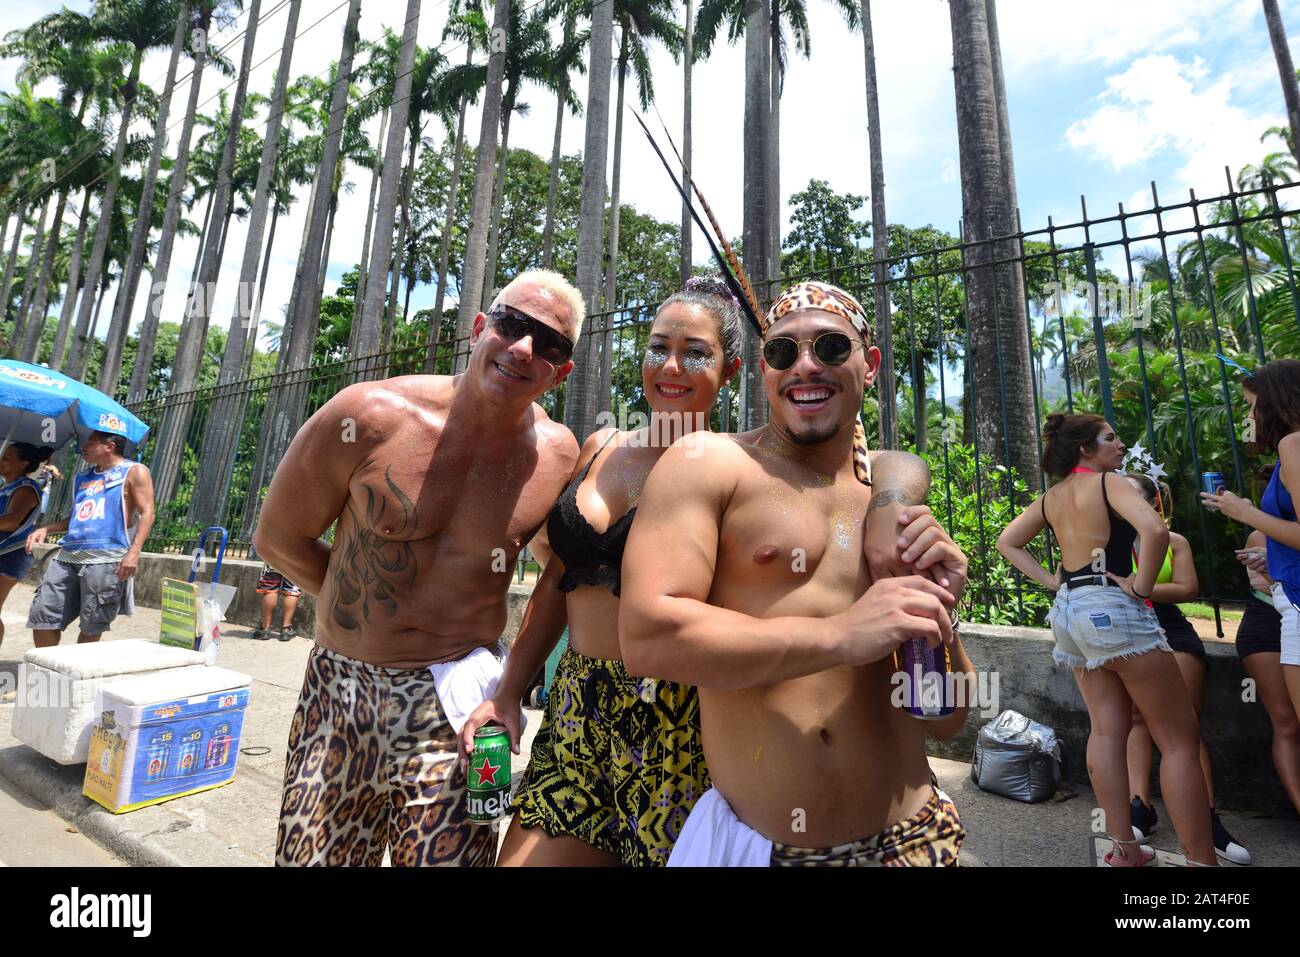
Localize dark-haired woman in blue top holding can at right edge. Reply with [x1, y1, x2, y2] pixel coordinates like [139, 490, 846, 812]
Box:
[1201, 359, 1300, 728]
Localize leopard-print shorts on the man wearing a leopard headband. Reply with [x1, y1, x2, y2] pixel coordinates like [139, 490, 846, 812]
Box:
[772, 788, 966, 867]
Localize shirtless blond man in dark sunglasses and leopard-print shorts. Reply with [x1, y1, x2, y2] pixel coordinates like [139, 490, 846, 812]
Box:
[254, 272, 584, 866]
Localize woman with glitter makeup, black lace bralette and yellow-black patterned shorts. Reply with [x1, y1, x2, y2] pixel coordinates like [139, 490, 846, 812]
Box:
[460, 278, 741, 866]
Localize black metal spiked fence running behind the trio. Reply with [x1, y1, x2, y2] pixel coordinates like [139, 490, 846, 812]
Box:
[43, 171, 1300, 622]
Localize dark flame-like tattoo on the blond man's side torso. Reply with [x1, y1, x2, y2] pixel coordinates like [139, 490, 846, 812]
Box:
[330, 465, 419, 631]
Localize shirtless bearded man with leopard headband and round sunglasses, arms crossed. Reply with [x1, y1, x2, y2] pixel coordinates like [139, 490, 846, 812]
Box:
[619, 283, 971, 866]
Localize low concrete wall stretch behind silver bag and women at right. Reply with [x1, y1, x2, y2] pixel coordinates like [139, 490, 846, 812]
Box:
[930, 622, 1295, 818]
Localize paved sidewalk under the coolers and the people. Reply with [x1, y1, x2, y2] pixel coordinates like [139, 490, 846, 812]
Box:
[0, 584, 1300, 867]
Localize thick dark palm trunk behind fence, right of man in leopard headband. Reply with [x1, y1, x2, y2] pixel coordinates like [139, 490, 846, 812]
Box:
[948, 0, 1040, 488]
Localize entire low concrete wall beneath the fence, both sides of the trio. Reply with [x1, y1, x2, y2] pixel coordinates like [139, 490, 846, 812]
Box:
[27, 546, 1295, 817]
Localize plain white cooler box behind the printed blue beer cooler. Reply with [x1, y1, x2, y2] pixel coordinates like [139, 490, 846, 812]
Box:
[13, 638, 204, 765]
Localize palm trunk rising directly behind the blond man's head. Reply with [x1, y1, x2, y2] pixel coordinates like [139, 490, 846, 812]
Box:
[455, 0, 512, 372]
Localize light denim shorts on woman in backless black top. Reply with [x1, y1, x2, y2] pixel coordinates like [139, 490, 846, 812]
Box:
[1048, 585, 1171, 670]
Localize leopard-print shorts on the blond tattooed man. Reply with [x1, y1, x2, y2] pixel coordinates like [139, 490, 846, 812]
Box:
[276, 645, 497, 867]
